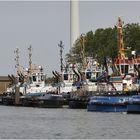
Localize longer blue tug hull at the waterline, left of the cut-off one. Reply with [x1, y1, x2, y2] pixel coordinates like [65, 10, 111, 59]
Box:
[87, 96, 130, 112]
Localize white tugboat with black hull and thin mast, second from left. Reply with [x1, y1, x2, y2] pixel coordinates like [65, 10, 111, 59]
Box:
[20, 48, 64, 108]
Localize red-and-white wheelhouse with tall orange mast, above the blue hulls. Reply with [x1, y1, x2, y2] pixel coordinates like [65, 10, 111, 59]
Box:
[113, 17, 140, 91]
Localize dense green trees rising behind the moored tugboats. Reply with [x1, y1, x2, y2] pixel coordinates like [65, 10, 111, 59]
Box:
[66, 23, 140, 64]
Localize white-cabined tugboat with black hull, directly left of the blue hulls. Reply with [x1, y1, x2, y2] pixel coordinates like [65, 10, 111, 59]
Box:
[69, 57, 102, 108]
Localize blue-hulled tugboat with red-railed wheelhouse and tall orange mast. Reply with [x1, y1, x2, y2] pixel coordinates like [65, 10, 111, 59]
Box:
[87, 17, 140, 112]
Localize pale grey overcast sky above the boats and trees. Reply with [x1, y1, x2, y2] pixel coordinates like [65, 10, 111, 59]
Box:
[0, 1, 140, 76]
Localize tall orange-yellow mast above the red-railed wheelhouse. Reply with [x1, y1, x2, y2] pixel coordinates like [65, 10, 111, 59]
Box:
[117, 17, 126, 59]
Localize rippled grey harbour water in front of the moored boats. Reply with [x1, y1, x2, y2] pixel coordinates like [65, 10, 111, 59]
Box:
[0, 106, 140, 139]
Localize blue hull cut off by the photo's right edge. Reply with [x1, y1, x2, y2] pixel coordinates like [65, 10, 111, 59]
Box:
[127, 95, 140, 113]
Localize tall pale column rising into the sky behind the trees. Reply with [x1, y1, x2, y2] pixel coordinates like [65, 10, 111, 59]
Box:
[70, 0, 79, 49]
